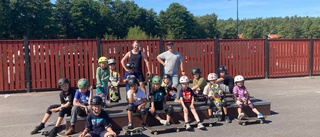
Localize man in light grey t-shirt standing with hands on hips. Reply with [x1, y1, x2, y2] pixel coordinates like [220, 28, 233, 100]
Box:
[157, 42, 185, 88]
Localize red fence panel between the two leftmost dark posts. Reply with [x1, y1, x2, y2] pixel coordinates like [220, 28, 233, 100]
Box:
[29, 40, 97, 89]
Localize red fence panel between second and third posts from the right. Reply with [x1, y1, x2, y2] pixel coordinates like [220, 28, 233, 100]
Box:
[219, 39, 265, 78]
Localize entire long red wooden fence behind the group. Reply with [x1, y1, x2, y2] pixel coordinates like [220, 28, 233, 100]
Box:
[0, 39, 320, 91]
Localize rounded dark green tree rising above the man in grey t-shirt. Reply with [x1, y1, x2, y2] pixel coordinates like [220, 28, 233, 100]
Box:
[159, 3, 196, 39]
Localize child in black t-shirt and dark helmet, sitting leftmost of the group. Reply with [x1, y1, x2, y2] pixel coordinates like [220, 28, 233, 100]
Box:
[31, 78, 76, 137]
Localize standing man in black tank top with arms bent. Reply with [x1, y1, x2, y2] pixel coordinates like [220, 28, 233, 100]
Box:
[121, 40, 151, 93]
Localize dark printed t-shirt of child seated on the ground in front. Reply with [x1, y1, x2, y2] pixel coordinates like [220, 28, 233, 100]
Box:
[86, 111, 112, 135]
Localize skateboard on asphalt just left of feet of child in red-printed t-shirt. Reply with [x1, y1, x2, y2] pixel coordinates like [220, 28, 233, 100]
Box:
[146, 123, 185, 135]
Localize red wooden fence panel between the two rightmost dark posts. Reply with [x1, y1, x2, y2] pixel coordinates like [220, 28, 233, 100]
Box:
[269, 39, 310, 77]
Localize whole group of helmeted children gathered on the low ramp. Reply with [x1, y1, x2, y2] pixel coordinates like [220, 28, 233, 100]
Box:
[31, 57, 263, 137]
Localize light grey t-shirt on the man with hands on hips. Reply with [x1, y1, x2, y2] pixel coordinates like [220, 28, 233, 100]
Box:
[158, 50, 183, 74]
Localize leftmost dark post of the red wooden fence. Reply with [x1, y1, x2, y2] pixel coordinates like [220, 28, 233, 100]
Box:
[23, 36, 32, 93]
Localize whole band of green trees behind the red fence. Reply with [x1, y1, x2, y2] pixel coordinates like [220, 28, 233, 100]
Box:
[0, 0, 320, 39]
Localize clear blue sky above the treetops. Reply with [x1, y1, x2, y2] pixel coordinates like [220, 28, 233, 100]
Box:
[51, 0, 320, 19]
